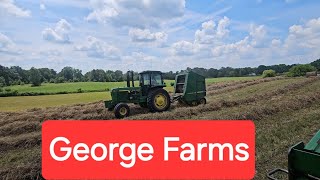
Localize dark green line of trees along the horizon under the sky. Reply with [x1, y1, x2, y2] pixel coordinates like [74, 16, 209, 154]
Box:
[0, 59, 320, 87]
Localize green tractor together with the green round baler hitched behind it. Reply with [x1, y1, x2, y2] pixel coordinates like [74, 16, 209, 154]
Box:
[105, 71, 206, 118]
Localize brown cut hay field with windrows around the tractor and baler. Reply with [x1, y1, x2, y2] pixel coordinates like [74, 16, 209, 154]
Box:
[0, 77, 320, 179]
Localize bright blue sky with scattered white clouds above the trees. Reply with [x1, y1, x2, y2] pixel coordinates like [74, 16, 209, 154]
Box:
[0, 0, 320, 72]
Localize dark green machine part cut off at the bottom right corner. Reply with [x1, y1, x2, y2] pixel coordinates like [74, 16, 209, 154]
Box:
[267, 130, 320, 180]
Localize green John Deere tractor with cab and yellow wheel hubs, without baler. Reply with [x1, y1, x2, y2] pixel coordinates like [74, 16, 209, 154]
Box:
[105, 71, 171, 118]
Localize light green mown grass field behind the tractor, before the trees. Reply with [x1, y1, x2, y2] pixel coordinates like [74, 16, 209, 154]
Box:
[0, 77, 260, 111]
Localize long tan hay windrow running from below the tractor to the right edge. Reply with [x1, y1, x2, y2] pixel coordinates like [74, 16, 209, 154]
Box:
[129, 78, 319, 119]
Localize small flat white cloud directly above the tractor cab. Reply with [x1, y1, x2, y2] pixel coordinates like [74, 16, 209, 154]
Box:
[129, 28, 168, 43]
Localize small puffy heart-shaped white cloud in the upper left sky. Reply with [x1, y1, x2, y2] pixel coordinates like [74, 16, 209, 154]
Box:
[42, 19, 72, 43]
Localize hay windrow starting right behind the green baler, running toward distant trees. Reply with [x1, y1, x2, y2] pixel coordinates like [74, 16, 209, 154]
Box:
[207, 77, 284, 96]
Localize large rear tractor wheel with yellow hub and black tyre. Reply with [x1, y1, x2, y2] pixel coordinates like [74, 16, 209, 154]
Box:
[147, 89, 171, 112]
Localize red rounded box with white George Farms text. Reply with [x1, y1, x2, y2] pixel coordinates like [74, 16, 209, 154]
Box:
[42, 120, 255, 179]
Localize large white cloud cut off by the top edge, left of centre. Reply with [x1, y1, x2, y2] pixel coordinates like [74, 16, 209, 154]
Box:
[86, 0, 185, 28]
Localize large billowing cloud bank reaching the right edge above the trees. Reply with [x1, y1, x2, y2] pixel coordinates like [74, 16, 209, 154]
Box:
[212, 18, 320, 66]
